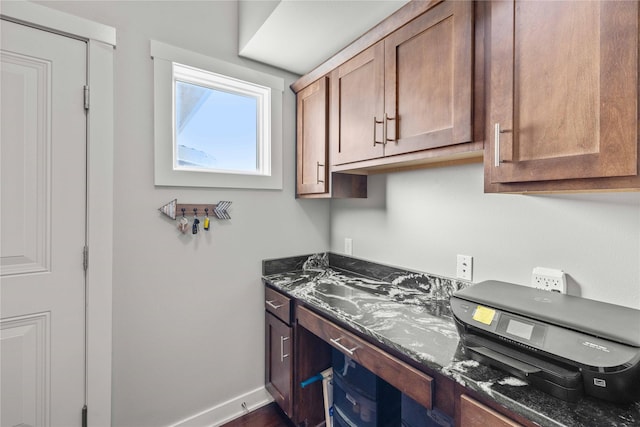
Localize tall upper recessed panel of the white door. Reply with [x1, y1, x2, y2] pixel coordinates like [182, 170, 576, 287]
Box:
[0, 51, 51, 276]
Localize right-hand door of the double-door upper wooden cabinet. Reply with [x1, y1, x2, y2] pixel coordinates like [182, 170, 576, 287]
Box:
[385, 1, 473, 156]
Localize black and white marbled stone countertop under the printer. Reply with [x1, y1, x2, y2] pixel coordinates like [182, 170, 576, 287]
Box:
[263, 253, 640, 427]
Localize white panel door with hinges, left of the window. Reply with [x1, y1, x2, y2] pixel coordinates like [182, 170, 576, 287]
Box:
[0, 20, 87, 427]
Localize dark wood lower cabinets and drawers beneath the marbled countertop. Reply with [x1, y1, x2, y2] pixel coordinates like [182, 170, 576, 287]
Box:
[265, 287, 534, 427]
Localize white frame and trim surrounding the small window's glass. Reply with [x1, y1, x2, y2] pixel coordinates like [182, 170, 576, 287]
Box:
[151, 40, 284, 190]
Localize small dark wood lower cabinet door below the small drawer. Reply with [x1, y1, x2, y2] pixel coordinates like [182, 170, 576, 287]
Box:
[265, 312, 293, 417]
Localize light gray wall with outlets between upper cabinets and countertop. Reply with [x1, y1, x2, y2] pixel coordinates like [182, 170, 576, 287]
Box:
[331, 164, 640, 308]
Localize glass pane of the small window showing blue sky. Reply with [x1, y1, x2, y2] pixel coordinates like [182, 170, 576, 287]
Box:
[175, 81, 259, 173]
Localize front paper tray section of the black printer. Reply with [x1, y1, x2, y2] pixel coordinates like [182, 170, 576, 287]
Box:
[465, 334, 583, 401]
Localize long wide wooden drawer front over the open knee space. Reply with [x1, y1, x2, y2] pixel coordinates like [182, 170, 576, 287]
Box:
[296, 307, 434, 409]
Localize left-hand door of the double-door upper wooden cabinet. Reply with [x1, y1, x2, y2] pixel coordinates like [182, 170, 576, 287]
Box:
[331, 42, 384, 165]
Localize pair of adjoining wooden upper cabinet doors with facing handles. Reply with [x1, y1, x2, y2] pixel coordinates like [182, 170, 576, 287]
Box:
[330, 1, 473, 169]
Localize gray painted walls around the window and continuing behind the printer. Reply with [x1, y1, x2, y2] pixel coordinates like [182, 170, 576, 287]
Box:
[32, 1, 640, 427]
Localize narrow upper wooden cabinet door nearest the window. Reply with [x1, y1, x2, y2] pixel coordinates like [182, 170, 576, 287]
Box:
[296, 77, 329, 194]
